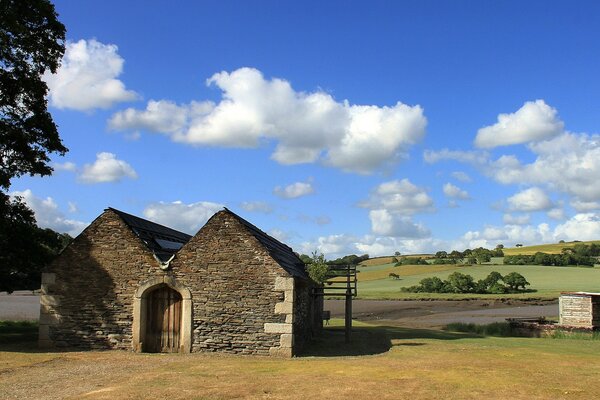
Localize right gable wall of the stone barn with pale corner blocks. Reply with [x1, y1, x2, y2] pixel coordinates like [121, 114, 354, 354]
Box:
[171, 212, 293, 356]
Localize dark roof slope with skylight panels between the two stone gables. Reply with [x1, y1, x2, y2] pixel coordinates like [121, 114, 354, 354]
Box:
[108, 207, 192, 261]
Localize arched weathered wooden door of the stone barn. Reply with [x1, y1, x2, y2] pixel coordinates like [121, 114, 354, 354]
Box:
[144, 286, 181, 353]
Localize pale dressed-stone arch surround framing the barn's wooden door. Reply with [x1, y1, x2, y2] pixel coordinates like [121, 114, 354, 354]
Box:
[132, 276, 192, 353]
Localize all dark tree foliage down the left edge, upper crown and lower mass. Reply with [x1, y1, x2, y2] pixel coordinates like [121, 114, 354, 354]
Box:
[0, 0, 68, 292]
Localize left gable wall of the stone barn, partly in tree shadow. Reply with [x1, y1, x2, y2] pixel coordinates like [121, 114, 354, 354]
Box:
[40, 211, 160, 349]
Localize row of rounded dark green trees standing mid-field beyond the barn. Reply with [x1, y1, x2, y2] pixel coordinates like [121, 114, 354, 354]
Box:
[401, 271, 530, 294]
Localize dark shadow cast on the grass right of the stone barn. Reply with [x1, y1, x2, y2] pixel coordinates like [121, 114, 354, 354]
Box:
[299, 325, 481, 357]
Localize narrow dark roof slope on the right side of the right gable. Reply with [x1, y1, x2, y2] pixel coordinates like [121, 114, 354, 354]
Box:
[220, 208, 308, 279]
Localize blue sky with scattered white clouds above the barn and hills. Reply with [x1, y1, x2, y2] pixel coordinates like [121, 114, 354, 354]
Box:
[10, 0, 600, 258]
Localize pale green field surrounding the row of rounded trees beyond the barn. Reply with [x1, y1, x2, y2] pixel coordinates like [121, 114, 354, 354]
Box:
[358, 263, 600, 299]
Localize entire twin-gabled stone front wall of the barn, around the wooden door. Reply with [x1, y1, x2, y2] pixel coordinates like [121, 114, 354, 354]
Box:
[40, 210, 313, 357]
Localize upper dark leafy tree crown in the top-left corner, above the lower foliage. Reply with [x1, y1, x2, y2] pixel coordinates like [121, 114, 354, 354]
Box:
[0, 0, 67, 189]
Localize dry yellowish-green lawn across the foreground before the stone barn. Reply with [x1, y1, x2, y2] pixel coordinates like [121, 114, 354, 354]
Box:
[0, 320, 600, 400]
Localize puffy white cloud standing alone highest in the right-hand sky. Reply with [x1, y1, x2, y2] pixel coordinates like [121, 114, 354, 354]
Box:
[475, 100, 564, 148]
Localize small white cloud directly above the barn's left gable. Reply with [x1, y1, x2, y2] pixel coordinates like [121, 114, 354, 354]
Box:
[78, 152, 137, 183]
